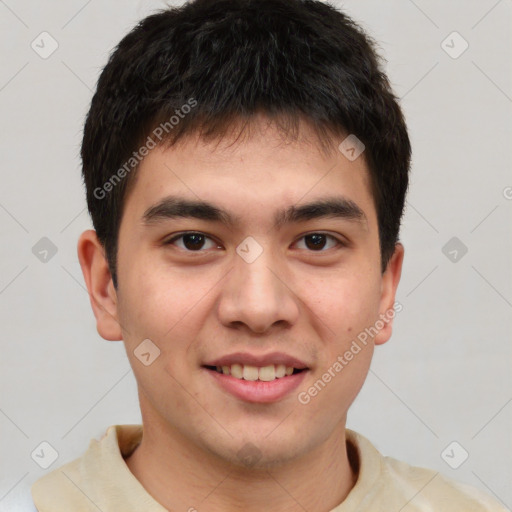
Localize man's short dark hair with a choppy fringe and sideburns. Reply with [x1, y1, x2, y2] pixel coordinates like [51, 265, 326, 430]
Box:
[81, 0, 411, 286]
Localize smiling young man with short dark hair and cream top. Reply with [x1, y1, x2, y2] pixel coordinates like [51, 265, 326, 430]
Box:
[32, 0, 504, 512]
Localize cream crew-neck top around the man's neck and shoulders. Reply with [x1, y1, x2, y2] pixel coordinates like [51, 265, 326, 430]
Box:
[31, 425, 507, 512]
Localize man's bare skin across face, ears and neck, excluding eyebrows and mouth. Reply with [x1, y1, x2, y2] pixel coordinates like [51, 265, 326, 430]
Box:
[78, 118, 404, 512]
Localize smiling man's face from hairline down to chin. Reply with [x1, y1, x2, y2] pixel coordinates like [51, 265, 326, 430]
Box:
[80, 118, 402, 467]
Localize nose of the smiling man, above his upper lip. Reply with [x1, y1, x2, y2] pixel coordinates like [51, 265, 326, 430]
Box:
[218, 251, 299, 334]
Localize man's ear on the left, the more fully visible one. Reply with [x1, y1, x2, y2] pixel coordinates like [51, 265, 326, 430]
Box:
[78, 229, 123, 341]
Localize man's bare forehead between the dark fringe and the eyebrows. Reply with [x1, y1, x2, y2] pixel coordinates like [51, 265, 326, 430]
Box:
[125, 120, 375, 227]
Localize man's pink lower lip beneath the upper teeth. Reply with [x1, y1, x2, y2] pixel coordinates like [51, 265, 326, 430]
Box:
[205, 368, 308, 403]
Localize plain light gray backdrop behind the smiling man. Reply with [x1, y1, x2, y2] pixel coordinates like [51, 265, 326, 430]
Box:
[0, 0, 512, 511]
